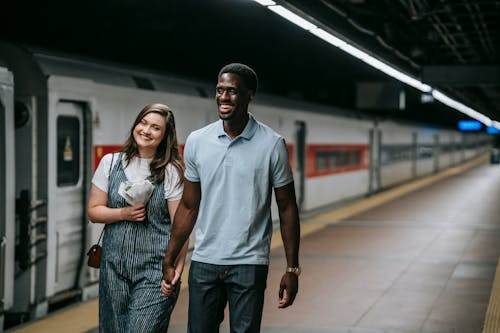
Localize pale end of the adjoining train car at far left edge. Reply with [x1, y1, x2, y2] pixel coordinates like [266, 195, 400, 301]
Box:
[0, 67, 15, 332]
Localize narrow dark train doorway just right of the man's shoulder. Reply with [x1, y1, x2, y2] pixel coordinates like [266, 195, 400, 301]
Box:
[295, 121, 306, 211]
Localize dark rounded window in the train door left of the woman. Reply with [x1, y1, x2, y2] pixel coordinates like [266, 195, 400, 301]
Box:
[57, 116, 80, 186]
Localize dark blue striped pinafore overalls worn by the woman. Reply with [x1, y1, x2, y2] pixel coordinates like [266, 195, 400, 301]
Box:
[99, 153, 176, 333]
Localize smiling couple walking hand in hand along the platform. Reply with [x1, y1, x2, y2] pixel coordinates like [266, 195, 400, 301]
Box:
[88, 63, 300, 333]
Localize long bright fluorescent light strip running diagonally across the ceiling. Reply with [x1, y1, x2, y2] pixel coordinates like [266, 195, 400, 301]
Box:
[253, 0, 500, 129]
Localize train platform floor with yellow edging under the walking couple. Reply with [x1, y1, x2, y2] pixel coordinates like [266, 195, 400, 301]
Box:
[7, 156, 500, 333]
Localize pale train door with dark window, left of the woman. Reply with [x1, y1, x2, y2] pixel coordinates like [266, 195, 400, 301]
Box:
[47, 101, 87, 295]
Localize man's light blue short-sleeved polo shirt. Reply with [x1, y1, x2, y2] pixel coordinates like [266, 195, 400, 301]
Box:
[184, 114, 293, 265]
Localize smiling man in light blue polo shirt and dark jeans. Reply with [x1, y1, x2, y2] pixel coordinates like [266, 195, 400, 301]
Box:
[163, 63, 300, 333]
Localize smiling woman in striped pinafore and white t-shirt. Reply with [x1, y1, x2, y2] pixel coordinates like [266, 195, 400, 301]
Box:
[88, 104, 187, 333]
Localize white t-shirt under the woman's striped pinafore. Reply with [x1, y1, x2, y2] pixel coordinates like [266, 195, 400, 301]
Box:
[92, 153, 183, 201]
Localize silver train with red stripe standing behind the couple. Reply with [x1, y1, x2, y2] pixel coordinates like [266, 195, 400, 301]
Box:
[0, 42, 492, 331]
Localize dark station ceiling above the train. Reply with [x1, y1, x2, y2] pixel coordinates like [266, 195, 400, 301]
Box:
[0, 0, 500, 127]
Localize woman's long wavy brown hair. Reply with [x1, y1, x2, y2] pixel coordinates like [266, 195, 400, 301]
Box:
[122, 103, 184, 186]
